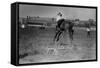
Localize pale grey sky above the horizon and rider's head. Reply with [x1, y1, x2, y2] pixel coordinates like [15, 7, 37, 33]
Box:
[19, 5, 96, 20]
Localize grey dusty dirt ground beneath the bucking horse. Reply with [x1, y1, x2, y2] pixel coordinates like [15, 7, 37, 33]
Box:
[19, 27, 96, 64]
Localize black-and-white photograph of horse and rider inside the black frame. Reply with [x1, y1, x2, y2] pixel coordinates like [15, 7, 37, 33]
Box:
[18, 4, 97, 64]
